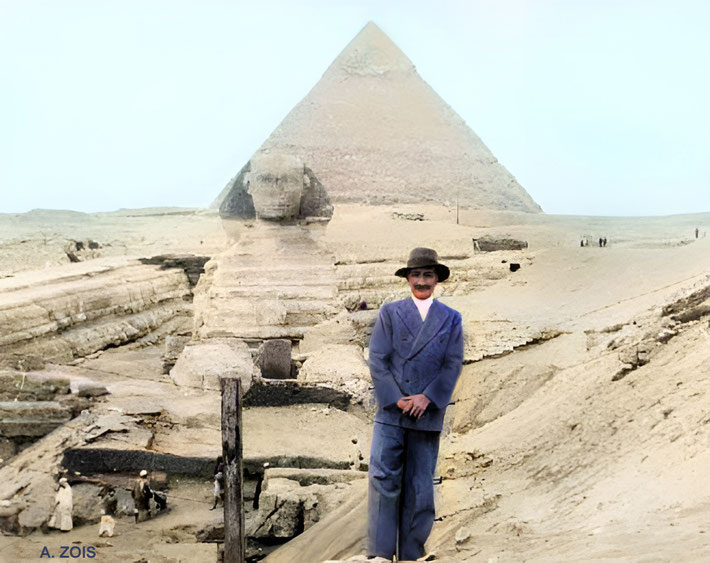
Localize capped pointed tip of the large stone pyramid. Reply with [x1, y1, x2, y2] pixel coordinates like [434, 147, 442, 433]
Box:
[326, 21, 414, 76]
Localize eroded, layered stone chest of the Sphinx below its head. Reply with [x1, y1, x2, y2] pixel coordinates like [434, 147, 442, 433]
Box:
[193, 228, 339, 340]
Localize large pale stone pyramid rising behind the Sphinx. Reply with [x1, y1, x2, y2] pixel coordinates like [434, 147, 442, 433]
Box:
[259, 22, 541, 212]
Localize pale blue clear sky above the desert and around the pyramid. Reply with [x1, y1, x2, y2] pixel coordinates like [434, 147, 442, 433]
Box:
[0, 0, 710, 215]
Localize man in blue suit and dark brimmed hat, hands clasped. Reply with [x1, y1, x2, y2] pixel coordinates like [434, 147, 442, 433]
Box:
[368, 248, 463, 561]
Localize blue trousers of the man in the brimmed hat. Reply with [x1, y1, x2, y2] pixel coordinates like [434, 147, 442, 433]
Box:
[367, 422, 439, 561]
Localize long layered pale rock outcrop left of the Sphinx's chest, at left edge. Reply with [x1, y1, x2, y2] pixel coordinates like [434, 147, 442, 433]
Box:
[0, 259, 191, 363]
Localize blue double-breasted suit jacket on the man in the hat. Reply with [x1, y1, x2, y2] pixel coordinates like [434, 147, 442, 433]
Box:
[369, 298, 463, 431]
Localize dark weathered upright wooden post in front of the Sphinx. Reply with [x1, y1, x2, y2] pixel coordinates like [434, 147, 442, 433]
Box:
[219, 377, 246, 563]
